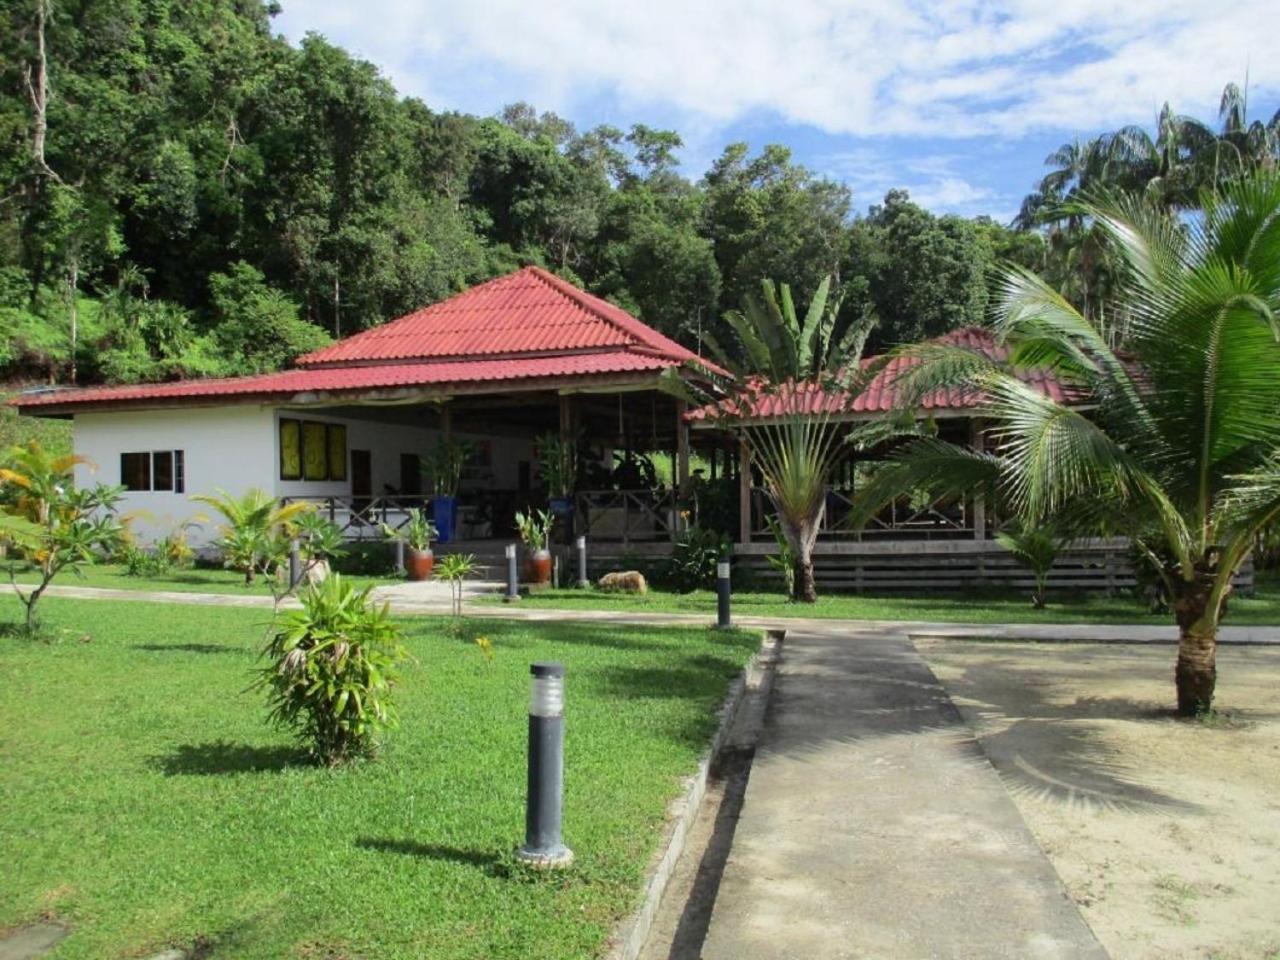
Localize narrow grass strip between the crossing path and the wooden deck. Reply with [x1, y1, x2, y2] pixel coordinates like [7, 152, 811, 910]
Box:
[494, 571, 1280, 625]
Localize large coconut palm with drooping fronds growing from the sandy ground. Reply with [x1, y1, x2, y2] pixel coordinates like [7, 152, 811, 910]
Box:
[854, 174, 1280, 714]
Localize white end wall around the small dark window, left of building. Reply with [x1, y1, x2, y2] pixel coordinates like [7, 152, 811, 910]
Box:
[74, 406, 279, 544]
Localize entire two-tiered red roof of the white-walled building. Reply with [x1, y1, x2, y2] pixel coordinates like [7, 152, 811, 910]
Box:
[10, 266, 722, 413]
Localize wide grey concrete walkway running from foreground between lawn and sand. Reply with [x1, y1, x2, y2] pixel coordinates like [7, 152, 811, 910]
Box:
[703, 628, 1106, 960]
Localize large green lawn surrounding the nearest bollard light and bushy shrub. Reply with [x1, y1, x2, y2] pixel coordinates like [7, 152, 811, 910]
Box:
[0, 596, 758, 960]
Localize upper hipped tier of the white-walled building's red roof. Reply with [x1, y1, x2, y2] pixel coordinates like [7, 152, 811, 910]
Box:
[298, 266, 696, 366]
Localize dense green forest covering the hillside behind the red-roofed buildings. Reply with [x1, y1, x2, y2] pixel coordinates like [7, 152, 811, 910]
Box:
[0, 0, 1280, 384]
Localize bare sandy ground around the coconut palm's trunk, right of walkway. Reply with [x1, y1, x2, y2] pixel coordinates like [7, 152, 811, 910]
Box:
[915, 637, 1280, 960]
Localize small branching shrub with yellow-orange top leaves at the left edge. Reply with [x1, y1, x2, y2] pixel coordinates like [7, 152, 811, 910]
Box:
[0, 440, 124, 632]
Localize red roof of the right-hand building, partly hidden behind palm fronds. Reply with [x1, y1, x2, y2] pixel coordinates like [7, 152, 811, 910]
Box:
[689, 326, 1078, 420]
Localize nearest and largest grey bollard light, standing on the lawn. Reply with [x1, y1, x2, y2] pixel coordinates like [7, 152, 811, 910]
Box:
[516, 663, 573, 869]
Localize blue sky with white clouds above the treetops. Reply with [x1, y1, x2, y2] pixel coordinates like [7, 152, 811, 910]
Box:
[275, 0, 1280, 220]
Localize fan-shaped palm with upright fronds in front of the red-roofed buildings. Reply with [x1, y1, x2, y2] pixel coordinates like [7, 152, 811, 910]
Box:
[700, 276, 876, 603]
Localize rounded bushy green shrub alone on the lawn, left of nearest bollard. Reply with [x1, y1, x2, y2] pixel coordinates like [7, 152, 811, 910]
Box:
[256, 576, 408, 765]
